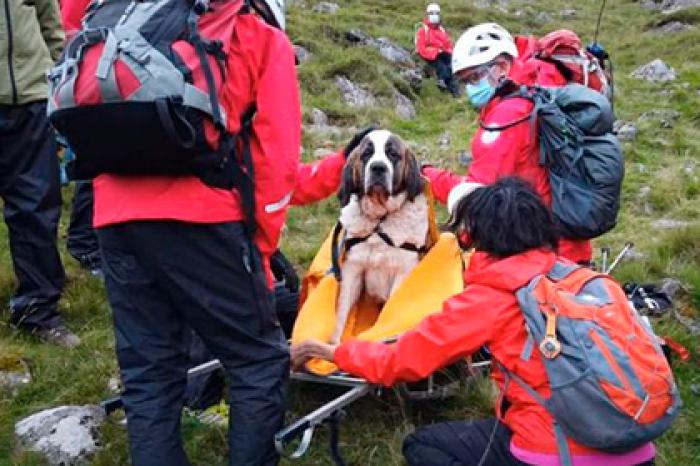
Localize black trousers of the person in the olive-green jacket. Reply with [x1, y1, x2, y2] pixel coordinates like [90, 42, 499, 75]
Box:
[0, 102, 65, 328]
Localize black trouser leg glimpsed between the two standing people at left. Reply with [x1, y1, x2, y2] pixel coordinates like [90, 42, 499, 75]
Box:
[66, 181, 100, 264]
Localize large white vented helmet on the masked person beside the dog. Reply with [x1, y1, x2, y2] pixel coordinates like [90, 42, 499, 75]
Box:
[452, 23, 518, 73]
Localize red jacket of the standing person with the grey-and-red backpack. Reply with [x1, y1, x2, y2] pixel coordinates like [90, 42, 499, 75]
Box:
[88, 12, 301, 278]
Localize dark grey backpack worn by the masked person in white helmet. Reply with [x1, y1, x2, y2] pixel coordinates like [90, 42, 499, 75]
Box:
[481, 84, 625, 239]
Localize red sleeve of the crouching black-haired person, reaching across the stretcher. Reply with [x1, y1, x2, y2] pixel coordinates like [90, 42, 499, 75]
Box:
[333, 285, 501, 386]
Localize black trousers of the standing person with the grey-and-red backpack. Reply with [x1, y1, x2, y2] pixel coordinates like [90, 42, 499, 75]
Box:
[98, 221, 289, 466]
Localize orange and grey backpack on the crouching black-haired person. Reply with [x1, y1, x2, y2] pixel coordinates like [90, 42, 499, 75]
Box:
[500, 262, 681, 466]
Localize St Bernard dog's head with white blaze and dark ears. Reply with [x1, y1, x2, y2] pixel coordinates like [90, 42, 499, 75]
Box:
[340, 130, 423, 206]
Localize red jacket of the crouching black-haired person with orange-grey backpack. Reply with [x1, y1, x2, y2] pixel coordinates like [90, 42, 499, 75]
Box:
[334, 250, 595, 454]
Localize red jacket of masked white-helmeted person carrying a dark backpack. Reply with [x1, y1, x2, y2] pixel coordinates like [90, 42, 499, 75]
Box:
[423, 61, 592, 262]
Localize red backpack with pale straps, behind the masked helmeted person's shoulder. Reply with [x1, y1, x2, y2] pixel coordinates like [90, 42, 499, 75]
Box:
[534, 29, 613, 99]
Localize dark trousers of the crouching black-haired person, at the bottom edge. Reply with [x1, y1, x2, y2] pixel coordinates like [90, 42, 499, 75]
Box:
[403, 418, 654, 466]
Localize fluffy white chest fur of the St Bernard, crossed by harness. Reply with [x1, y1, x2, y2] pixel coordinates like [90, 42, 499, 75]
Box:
[340, 194, 428, 302]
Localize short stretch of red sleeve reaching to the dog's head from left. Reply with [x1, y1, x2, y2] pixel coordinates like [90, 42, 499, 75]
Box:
[290, 150, 345, 205]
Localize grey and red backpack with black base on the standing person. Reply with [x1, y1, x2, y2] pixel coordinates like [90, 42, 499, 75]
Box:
[48, 0, 255, 191]
